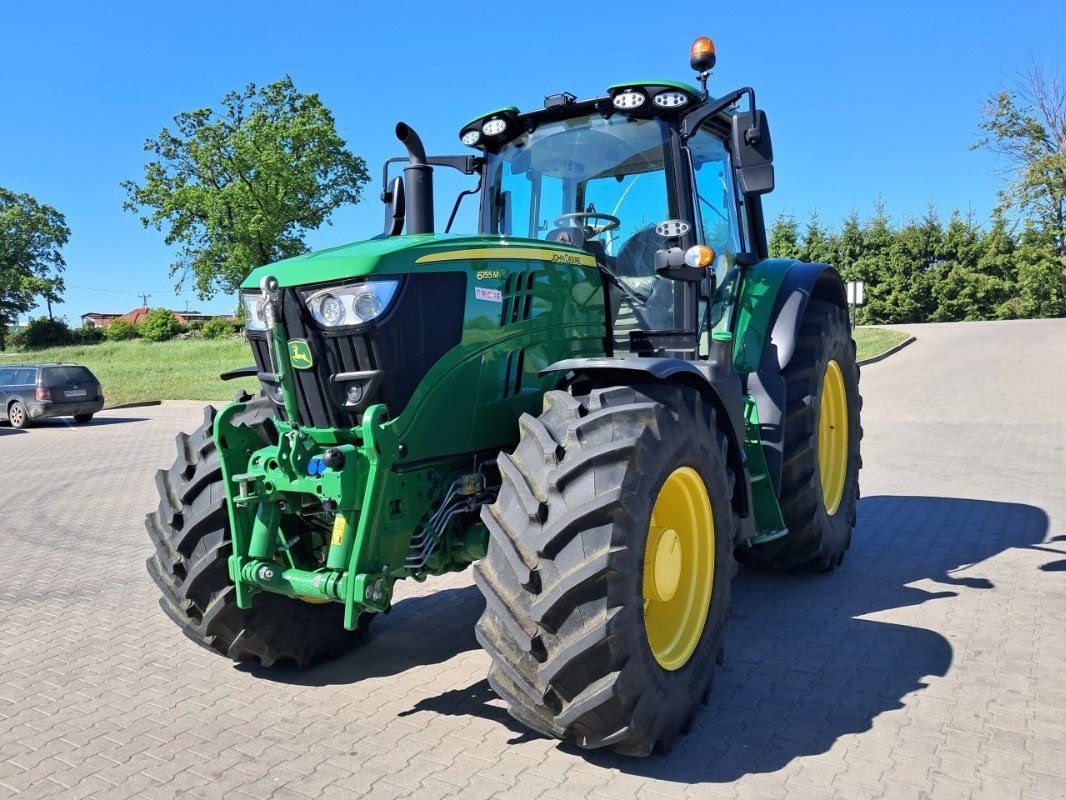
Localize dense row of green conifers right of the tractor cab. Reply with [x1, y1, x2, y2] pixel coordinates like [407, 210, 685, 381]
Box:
[770, 204, 1064, 323]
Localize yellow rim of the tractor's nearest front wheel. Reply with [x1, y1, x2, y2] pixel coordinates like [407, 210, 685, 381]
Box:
[644, 467, 714, 670]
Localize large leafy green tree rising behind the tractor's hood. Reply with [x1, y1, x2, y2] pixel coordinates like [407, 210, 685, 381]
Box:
[122, 76, 368, 299]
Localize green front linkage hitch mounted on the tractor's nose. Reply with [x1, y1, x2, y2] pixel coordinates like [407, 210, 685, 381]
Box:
[213, 277, 485, 630]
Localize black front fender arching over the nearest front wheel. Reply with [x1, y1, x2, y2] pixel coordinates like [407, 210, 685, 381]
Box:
[539, 357, 754, 542]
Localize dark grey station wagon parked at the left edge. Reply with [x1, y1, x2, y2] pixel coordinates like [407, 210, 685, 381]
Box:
[0, 364, 103, 428]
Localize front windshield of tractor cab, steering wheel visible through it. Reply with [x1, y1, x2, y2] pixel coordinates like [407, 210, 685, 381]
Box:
[483, 114, 681, 347]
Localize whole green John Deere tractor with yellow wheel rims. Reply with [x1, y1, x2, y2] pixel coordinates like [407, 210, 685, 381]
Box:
[147, 38, 861, 755]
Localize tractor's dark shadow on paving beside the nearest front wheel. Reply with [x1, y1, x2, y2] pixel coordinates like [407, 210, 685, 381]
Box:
[404, 496, 1048, 784]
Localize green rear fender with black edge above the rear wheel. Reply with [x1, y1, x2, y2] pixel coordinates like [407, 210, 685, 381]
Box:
[733, 258, 847, 496]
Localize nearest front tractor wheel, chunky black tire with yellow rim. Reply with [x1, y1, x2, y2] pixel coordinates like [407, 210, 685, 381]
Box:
[474, 386, 736, 755]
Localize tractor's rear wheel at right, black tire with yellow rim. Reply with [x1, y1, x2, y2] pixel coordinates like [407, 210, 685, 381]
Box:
[737, 300, 862, 572]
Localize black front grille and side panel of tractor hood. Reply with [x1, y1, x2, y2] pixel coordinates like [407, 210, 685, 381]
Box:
[248, 272, 466, 428]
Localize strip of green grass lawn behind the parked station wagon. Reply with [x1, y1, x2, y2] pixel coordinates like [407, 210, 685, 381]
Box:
[0, 338, 259, 407]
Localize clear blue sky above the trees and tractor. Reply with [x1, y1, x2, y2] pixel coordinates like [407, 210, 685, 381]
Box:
[0, 0, 1066, 323]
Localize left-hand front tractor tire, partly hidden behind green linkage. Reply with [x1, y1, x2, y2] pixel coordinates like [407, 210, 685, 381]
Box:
[145, 395, 371, 668]
